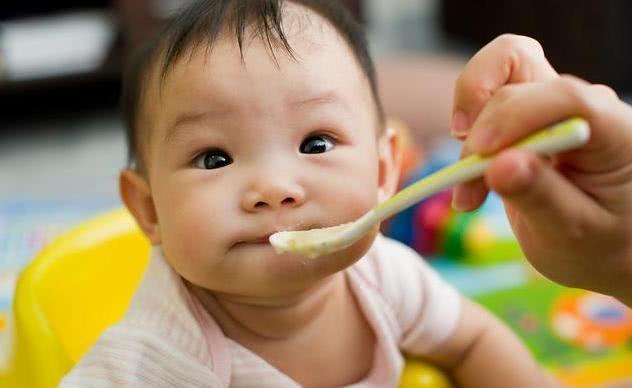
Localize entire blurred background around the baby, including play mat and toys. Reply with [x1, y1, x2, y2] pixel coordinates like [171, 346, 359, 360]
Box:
[0, 0, 632, 386]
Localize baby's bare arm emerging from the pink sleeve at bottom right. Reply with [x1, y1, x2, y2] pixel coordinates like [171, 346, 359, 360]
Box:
[452, 316, 557, 388]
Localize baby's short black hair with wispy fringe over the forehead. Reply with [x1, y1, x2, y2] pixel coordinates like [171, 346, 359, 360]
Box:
[121, 0, 385, 170]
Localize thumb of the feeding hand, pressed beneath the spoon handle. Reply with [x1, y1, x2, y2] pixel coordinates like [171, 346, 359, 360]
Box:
[485, 149, 607, 236]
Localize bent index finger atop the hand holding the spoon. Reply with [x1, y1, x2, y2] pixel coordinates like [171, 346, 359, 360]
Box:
[452, 34, 559, 138]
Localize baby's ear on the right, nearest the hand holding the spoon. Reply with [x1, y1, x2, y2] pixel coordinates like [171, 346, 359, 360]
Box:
[378, 125, 402, 202]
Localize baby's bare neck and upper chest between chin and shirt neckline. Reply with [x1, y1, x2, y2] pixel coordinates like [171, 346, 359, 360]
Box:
[188, 272, 376, 387]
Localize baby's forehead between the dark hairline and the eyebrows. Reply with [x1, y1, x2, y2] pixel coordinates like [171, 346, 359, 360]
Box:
[153, 44, 372, 131]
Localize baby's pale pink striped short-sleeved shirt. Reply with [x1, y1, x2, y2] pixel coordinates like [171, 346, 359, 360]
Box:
[61, 236, 460, 388]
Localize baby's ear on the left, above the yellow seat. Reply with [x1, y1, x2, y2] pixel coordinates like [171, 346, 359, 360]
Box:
[119, 169, 160, 245]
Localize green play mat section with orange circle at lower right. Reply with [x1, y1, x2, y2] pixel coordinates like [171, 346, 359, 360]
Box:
[472, 280, 632, 387]
